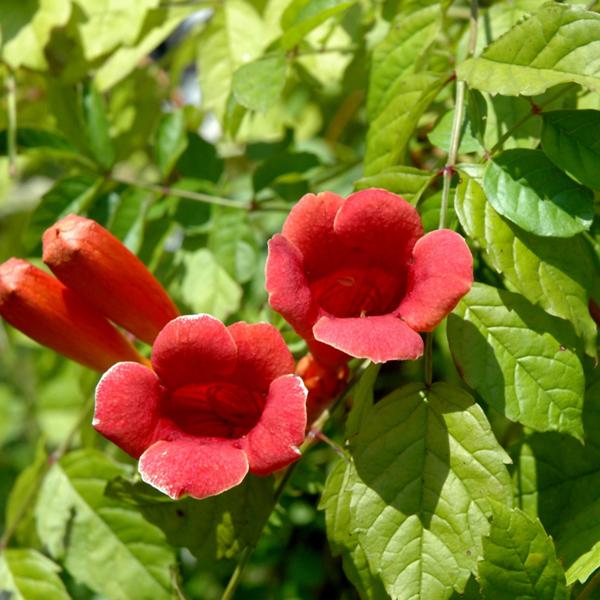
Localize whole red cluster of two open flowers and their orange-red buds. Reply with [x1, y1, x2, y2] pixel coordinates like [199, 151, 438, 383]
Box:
[0, 189, 473, 498]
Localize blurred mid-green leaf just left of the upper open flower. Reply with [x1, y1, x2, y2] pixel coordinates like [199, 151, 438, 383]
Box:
[207, 207, 258, 283]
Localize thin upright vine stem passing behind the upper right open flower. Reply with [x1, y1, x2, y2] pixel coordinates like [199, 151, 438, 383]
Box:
[424, 0, 479, 385]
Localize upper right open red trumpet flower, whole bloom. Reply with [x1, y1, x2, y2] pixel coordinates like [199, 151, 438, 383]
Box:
[266, 189, 473, 365]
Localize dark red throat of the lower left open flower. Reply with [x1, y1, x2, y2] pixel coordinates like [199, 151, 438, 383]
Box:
[161, 383, 265, 438]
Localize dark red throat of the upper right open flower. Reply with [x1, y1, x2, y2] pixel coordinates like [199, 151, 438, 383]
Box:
[310, 266, 404, 318]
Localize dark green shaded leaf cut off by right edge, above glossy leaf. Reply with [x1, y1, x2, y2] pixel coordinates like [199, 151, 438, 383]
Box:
[542, 110, 600, 190]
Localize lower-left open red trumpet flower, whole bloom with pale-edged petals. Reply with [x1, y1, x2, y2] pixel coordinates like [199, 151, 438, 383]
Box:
[93, 314, 307, 498]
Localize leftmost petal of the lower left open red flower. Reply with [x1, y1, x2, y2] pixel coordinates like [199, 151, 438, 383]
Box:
[92, 362, 164, 458]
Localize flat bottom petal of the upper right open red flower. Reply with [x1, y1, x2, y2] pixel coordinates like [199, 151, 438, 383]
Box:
[313, 315, 423, 363]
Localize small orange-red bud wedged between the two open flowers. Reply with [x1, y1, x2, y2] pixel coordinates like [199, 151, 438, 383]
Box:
[296, 354, 350, 426]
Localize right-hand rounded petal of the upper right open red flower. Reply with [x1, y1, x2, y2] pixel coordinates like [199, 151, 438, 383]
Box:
[396, 229, 473, 331]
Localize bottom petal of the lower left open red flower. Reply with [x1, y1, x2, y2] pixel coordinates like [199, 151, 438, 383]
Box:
[138, 438, 248, 500]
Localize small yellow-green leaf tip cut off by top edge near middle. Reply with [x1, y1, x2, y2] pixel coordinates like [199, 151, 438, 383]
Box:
[281, 0, 356, 50]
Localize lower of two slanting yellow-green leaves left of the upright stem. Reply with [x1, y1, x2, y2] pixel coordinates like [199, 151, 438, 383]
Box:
[365, 73, 445, 176]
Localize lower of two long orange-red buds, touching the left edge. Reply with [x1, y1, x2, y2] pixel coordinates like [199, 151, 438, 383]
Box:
[0, 258, 146, 371]
